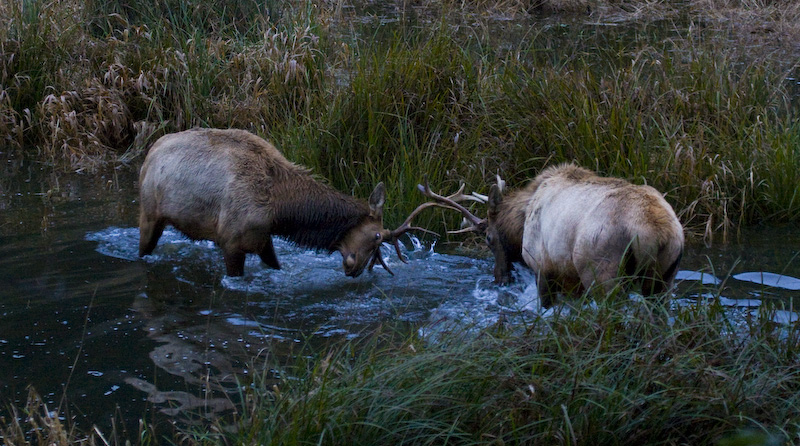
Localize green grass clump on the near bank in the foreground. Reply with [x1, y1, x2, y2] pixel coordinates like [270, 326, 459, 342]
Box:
[181, 300, 800, 445]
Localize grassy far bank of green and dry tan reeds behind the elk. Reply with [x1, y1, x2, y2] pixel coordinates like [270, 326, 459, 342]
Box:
[0, 0, 800, 237]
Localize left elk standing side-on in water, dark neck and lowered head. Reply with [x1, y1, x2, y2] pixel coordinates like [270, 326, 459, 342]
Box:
[139, 128, 432, 277]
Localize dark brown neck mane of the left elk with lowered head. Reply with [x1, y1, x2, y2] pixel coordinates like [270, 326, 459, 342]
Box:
[272, 175, 369, 252]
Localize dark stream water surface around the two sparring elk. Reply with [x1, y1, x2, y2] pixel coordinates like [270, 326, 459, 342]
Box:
[0, 159, 800, 427]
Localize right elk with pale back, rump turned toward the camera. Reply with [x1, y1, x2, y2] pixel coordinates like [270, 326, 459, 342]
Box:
[419, 164, 684, 308]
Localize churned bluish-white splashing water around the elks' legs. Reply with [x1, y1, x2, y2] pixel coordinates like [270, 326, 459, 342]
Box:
[86, 227, 800, 338]
